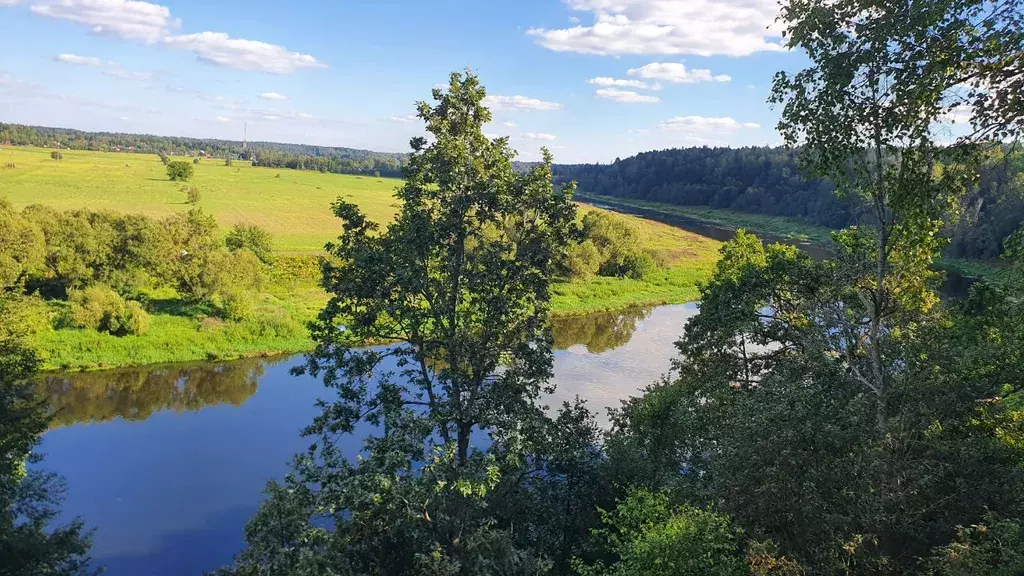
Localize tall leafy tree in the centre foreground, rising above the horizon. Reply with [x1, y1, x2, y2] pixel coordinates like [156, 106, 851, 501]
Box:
[221, 72, 596, 575]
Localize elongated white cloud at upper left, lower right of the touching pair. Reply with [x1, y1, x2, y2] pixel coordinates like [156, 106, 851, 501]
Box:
[163, 32, 327, 74]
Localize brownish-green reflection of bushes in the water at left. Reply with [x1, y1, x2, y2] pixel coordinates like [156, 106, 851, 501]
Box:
[39, 359, 280, 427]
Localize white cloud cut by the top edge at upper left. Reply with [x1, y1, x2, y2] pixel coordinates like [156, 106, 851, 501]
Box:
[31, 0, 177, 42]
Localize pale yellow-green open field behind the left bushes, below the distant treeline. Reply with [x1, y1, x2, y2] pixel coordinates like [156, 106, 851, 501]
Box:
[0, 147, 401, 252]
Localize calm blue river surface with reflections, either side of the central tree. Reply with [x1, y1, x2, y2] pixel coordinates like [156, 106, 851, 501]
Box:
[40, 304, 696, 576]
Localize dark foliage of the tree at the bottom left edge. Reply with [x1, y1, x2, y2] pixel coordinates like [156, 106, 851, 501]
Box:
[0, 292, 93, 576]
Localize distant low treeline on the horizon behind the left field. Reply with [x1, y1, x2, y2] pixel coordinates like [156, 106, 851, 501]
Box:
[0, 123, 406, 176]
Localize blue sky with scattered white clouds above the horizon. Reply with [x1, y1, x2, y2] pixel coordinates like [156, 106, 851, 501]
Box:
[0, 0, 804, 162]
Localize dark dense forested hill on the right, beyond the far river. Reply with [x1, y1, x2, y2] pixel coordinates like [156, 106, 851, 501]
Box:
[553, 147, 1024, 259]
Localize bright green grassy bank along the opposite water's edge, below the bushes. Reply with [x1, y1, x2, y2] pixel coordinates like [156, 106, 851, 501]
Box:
[32, 207, 721, 371]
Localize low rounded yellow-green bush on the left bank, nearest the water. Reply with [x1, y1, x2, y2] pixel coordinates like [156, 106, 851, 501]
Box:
[69, 284, 151, 336]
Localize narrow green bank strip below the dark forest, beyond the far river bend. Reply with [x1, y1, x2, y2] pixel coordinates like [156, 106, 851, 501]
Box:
[577, 194, 1007, 284]
